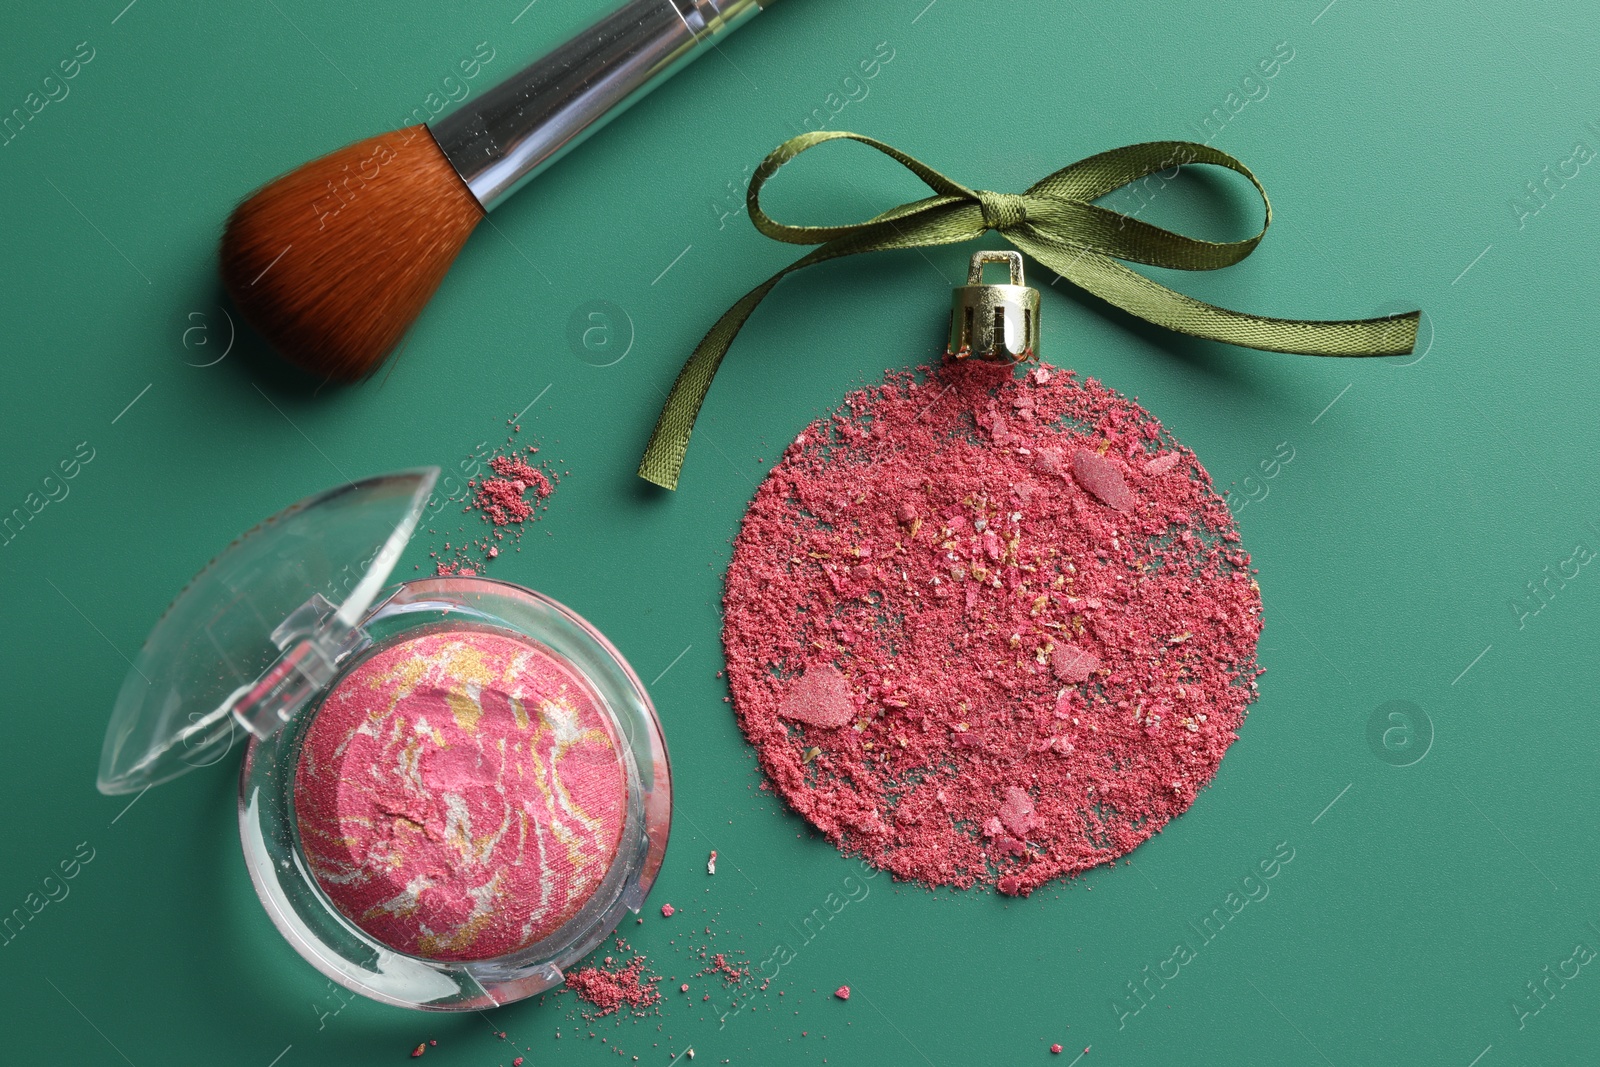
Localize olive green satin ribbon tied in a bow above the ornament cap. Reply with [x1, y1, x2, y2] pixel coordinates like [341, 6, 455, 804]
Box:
[638, 131, 1421, 490]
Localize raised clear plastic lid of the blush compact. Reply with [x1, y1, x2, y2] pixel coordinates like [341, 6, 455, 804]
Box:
[98, 467, 438, 793]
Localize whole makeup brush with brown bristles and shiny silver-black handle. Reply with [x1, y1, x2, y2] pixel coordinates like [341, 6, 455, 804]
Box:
[221, 0, 776, 381]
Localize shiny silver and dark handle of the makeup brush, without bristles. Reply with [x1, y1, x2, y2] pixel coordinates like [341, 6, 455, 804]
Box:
[429, 0, 774, 211]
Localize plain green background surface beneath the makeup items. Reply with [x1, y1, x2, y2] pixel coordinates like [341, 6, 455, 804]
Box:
[0, 0, 1600, 1067]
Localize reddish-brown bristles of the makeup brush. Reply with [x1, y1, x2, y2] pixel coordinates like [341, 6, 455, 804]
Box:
[221, 126, 483, 381]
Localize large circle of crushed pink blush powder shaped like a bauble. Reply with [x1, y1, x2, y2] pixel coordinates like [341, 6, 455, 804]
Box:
[723, 360, 1261, 894]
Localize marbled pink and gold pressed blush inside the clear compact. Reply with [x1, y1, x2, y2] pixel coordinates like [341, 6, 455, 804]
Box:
[294, 630, 627, 960]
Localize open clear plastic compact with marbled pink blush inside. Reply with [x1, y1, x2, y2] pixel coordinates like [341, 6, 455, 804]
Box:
[99, 469, 672, 1011]
